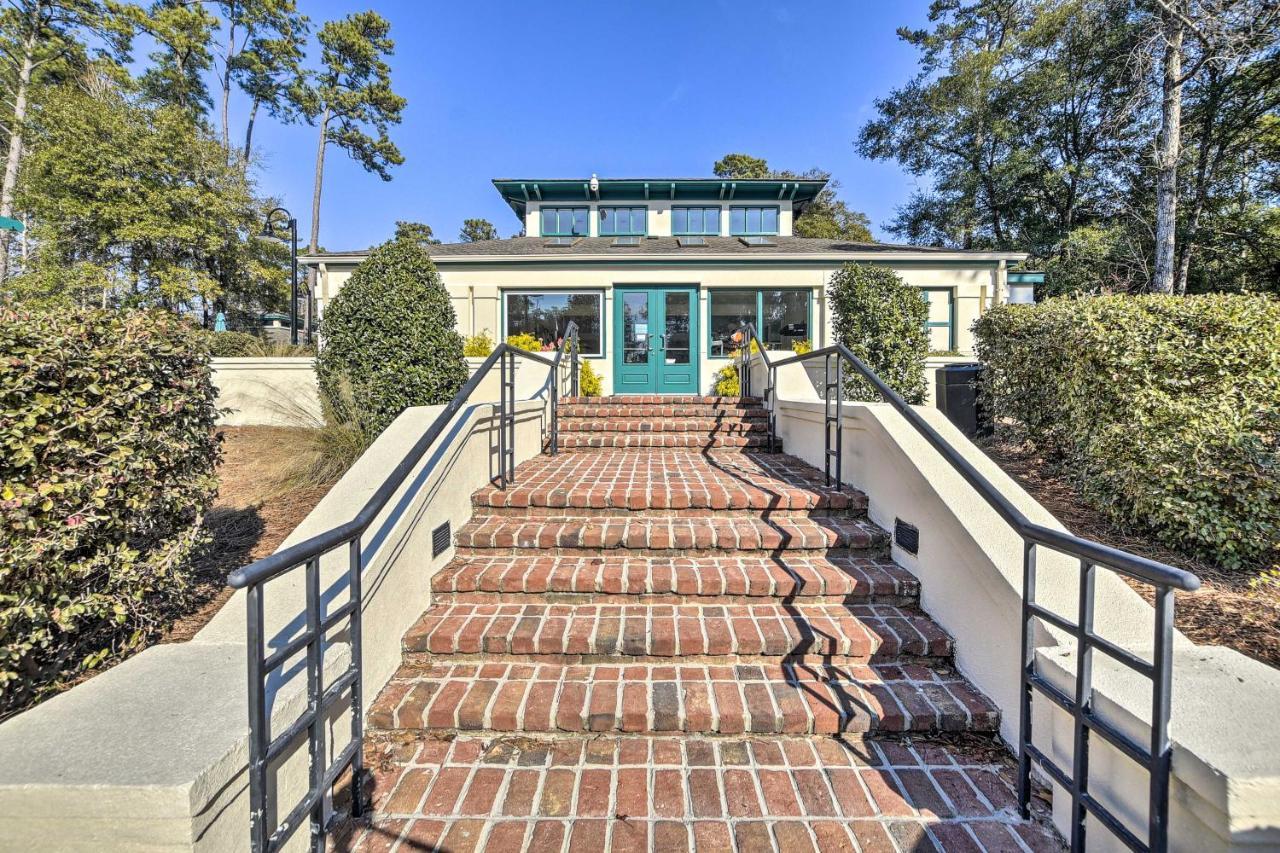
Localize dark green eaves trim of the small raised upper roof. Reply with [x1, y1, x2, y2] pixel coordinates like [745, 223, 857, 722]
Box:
[493, 178, 827, 222]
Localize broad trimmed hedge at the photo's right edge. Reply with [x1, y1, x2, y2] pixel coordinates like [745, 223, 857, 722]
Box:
[975, 295, 1280, 567]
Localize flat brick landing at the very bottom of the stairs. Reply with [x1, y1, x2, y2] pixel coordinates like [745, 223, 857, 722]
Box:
[343, 734, 1064, 853]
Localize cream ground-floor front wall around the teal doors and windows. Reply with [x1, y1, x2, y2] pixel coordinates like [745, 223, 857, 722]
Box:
[317, 263, 1001, 394]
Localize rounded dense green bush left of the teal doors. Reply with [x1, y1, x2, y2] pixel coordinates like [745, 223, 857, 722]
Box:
[316, 240, 467, 438]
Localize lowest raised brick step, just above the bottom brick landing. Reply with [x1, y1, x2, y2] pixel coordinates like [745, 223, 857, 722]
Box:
[369, 661, 1000, 735]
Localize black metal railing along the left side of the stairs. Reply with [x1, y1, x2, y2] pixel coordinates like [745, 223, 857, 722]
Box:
[228, 323, 579, 853]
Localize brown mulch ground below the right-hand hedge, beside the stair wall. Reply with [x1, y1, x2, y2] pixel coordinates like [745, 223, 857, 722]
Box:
[983, 441, 1280, 667]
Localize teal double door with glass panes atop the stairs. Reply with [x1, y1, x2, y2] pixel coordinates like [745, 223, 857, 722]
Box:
[613, 286, 699, 394]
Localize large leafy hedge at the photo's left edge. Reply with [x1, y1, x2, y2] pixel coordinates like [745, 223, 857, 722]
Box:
[0, 306, 219, 716]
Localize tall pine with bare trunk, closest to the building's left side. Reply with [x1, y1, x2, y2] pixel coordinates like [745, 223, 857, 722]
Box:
[303, 12, 406, 289]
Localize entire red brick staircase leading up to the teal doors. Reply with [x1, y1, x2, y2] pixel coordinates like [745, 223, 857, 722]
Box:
[350, 397, 1055, 849]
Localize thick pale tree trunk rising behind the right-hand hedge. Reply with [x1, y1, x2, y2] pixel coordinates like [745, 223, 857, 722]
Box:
[1151, 7, 1183, 293]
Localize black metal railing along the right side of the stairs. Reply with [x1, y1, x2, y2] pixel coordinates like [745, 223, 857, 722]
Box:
[739, 324, 1199, 852]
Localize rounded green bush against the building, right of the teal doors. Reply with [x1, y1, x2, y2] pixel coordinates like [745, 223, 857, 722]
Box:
[827, 264, 929, 403]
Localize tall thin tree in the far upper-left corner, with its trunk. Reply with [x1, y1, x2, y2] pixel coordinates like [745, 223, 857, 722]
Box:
[0, 0, 131, 282]
